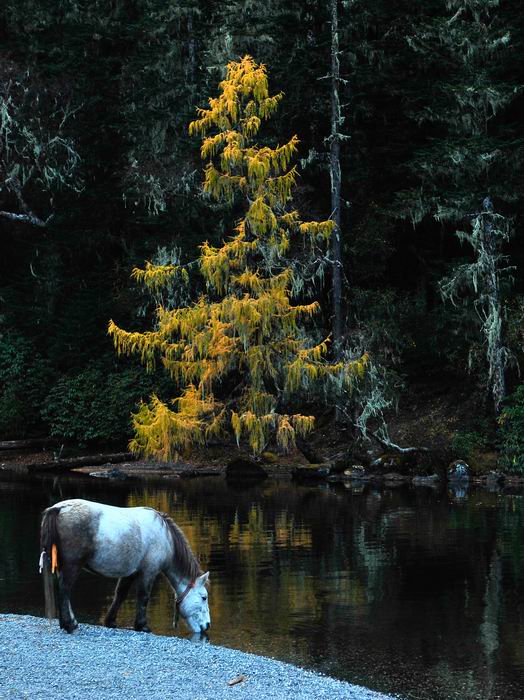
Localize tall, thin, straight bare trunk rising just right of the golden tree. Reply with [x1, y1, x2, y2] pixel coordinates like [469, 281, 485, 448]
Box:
[330, 0, 343, 357]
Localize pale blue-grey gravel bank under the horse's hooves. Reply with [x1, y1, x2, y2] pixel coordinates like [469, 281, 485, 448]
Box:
[0, 615, 400, 700]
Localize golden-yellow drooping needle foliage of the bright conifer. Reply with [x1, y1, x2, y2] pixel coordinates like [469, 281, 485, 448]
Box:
[109, 56, 366, 460]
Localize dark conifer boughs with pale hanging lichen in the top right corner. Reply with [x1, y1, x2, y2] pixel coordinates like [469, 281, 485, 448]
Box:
[399, 0, 524, 225]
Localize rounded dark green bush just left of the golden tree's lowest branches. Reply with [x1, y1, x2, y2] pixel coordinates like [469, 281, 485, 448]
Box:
[42, 362, 158, 445]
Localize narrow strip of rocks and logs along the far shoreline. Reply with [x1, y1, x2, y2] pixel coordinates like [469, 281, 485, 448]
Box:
[0, 440, 524, 491]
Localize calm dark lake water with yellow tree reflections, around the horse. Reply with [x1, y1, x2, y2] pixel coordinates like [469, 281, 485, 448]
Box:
[0, 477, 524, 700]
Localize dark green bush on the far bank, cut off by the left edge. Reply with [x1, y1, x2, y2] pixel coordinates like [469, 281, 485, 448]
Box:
[0, 334, 51, 439]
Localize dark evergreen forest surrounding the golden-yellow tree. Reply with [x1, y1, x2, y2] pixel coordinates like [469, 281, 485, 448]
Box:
[0, 0, 524, 471]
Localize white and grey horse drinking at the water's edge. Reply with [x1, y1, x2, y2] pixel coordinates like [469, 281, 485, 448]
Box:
[40, 498, 211, 634]
